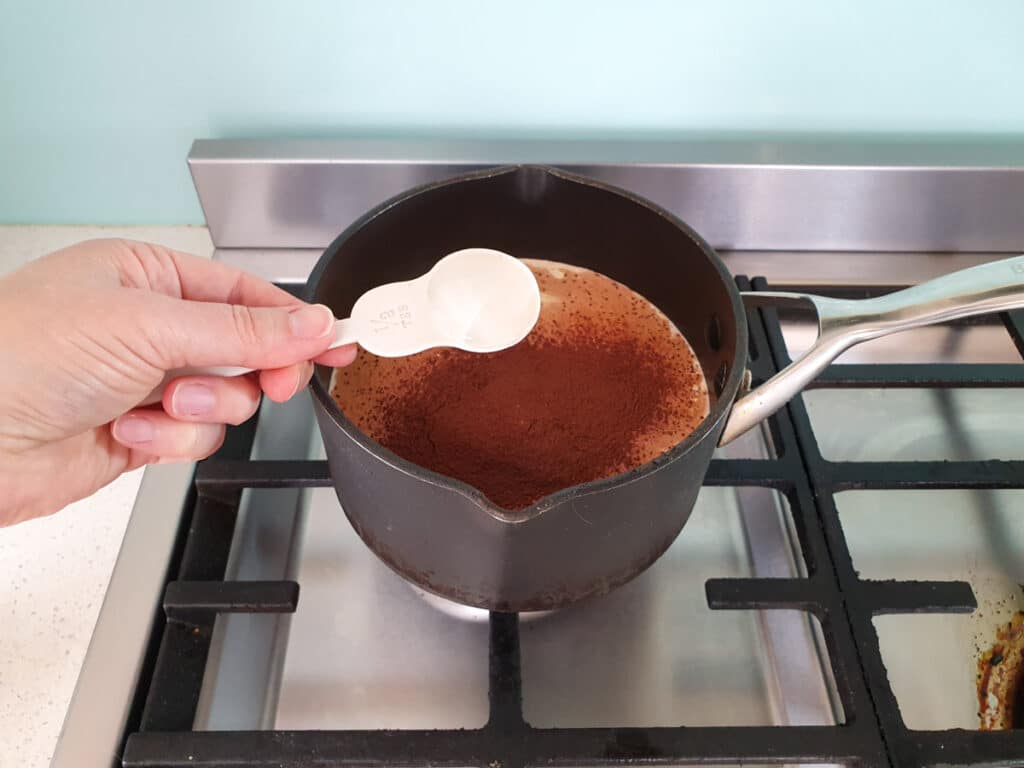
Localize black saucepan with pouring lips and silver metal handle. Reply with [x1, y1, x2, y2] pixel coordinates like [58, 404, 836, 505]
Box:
[306, 166, 1024, 611]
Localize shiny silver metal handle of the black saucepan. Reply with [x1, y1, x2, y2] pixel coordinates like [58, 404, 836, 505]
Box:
[719, 256, 1024, 445]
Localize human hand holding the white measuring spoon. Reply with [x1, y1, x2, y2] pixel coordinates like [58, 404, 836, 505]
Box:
[0, 240, 355, 525]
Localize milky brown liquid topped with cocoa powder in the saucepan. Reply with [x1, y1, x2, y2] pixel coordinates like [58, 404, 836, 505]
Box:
[334, 262, 708, 509]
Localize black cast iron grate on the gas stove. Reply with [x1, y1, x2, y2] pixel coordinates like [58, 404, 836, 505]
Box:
[116, 279, 1024, 768]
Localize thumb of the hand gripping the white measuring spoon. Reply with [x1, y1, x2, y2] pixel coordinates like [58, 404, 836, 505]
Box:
[145, 297, 334, 371]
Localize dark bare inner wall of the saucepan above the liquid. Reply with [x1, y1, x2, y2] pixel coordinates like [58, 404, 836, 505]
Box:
[311, 167, 745, 505]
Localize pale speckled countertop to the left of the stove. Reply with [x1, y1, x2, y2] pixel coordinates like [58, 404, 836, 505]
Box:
[0, 225, 213, 768]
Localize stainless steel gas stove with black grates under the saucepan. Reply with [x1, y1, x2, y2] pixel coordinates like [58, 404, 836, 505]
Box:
[52, 141, 1024, 768]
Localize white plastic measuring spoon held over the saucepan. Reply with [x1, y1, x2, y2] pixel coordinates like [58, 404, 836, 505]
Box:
[142, 248, 541, 404]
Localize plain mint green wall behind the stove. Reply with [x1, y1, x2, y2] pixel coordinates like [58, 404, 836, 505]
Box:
[0, 0, 1024, 223]
